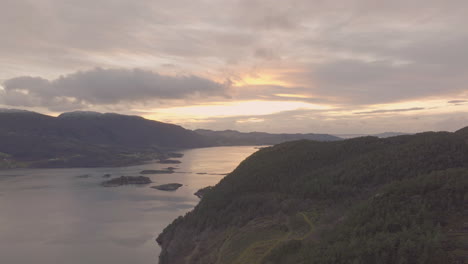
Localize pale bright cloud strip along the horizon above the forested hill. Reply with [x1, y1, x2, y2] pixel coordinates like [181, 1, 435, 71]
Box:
[184, 109, 468, 134]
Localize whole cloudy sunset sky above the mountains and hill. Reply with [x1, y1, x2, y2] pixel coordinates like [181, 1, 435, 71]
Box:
[0, 0, 468, 134]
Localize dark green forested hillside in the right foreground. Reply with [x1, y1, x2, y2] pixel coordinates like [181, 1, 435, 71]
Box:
[157, 128, 468, 264]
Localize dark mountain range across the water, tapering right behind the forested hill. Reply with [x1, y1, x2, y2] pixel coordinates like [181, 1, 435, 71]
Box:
[0, 109, 340, 168]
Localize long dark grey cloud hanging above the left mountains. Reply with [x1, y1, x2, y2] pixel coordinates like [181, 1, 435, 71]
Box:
[0, 68, 228, 111]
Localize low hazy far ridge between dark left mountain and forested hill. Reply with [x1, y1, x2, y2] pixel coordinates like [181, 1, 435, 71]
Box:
[195, 129, 341, 146]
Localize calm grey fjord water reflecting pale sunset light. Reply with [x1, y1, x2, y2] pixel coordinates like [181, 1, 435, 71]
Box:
[0, 146, 257, 264]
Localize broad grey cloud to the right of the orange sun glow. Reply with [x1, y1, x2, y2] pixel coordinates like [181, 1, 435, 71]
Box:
[270, 59, 468, 106]
